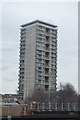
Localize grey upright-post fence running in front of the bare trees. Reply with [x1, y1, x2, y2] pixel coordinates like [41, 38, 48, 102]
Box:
[27, 102, 80, 111]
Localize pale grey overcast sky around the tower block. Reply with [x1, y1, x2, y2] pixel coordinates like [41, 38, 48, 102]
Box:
[0, 2, 78, 93]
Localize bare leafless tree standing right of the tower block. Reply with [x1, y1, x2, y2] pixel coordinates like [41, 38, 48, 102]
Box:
[57, 83, 78, 103]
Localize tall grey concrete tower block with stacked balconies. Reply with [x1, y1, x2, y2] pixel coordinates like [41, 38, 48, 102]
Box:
[19, 20, 57, 100]
